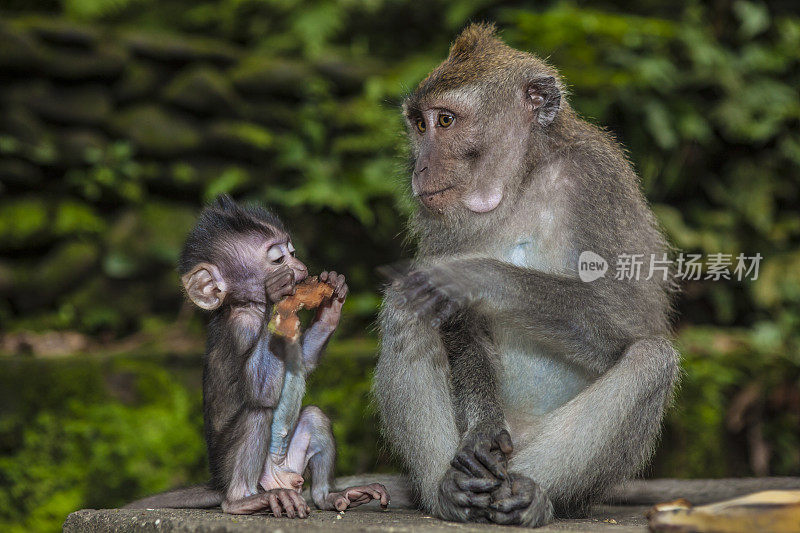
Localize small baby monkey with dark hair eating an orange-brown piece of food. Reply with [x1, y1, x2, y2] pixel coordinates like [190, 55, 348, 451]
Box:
[128, 196, 389, 518]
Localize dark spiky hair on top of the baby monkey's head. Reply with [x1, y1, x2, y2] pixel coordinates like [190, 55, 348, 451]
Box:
[178, 194, 286, 275]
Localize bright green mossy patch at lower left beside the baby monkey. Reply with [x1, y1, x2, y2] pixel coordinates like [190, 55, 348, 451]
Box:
[0, 359, 207, 531]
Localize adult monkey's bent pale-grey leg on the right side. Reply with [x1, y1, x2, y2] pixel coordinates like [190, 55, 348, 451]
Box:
[504, 338, 679, 523]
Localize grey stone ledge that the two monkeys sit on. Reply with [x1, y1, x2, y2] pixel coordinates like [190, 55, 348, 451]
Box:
[64, 474, 800, 533]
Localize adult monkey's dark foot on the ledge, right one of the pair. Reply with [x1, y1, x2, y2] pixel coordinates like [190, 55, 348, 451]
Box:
[487, 474, 553, 527]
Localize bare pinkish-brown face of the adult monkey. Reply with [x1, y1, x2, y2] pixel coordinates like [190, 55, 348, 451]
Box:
[406, 89, 531, 216]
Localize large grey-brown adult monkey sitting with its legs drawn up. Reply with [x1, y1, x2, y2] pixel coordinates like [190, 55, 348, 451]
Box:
[374, 25, 679, 526]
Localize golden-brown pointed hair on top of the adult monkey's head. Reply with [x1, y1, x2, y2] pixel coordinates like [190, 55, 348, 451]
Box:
[406, 23, 558, 109]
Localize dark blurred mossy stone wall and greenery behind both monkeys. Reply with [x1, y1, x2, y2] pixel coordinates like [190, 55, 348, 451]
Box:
[0, 0, 800, 531]
